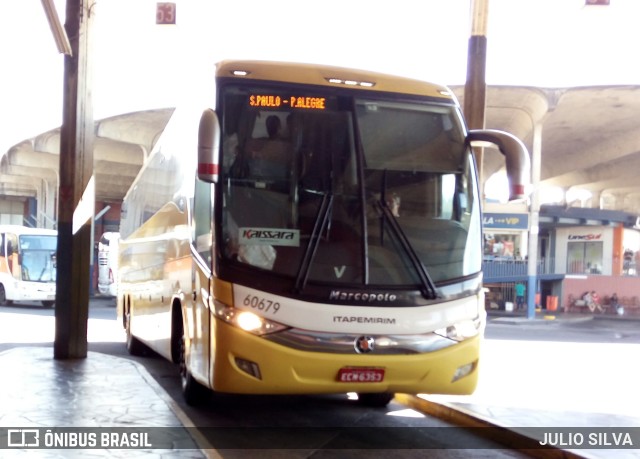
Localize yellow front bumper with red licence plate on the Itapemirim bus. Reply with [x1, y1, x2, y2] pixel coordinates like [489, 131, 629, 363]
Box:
[210, 320, 481, 395]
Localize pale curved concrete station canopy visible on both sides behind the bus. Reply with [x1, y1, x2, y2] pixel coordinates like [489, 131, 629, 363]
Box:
[0, 86, 640, 214]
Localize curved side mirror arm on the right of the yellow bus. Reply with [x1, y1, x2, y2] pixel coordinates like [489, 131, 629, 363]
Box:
[468, 129, 531, 201]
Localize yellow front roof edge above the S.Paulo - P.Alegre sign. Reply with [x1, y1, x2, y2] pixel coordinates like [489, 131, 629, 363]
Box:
[216, 60, 457, 103]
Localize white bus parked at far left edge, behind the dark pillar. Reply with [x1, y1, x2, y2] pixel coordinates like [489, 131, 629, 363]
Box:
[0, 225, 58, 307]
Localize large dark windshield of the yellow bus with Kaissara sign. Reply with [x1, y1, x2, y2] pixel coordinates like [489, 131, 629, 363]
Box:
[221, 85, 481, 295]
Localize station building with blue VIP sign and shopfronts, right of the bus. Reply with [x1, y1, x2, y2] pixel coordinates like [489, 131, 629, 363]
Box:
[483, 203, 640, 315]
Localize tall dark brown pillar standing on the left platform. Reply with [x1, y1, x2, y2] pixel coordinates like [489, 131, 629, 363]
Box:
[53, 0, 96, 359]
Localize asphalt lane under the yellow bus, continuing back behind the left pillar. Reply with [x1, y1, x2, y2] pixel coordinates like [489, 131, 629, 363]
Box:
[0, 300, 526, 458]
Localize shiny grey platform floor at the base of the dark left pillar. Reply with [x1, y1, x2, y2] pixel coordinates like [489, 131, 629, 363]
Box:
[0, 346, 207, 458]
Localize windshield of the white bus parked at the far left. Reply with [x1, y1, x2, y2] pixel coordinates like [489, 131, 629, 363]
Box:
[20, 235, 58, 282]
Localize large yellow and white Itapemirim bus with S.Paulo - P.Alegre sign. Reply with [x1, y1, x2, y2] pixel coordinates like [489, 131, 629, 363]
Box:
[117, 61, 528, 406]
